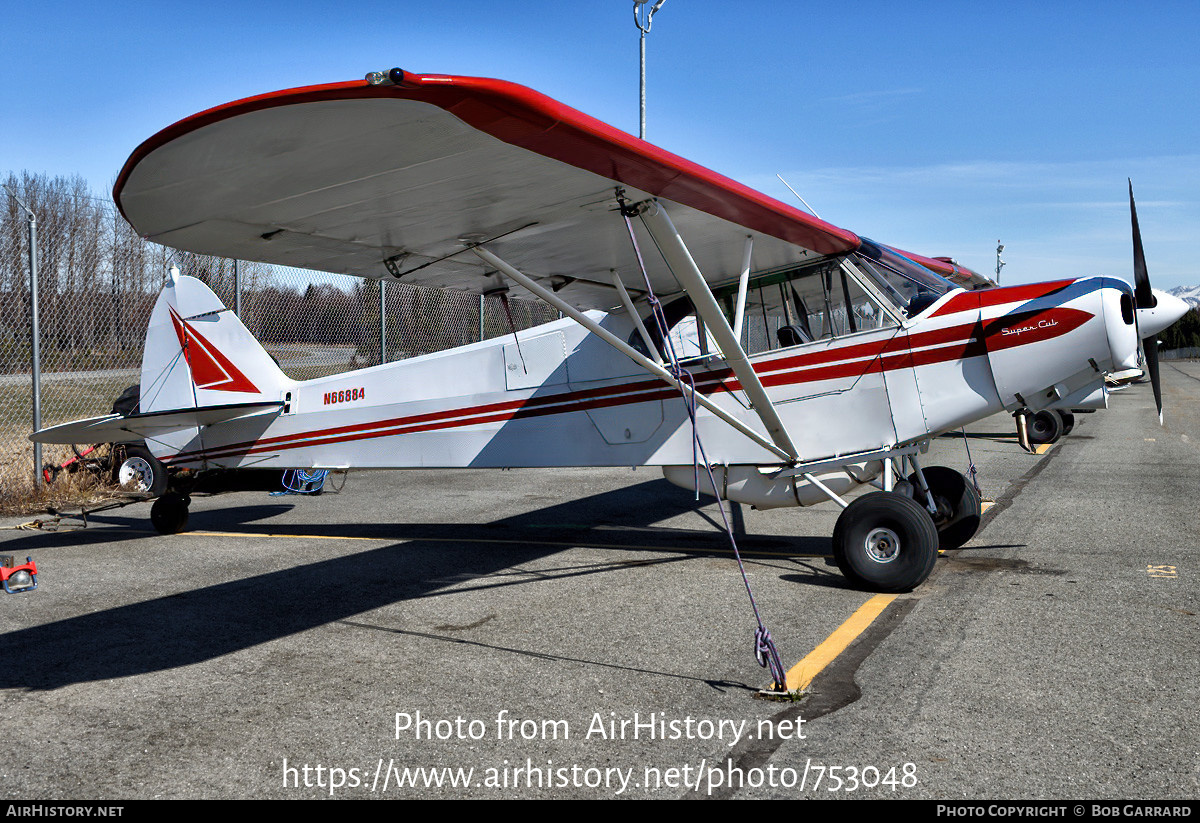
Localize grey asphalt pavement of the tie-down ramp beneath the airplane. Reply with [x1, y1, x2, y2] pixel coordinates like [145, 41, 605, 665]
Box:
[0, 361, 1200, 800]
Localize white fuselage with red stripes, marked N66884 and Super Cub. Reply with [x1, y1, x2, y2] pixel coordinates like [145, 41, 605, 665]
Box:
[151, 278, 1136, 489]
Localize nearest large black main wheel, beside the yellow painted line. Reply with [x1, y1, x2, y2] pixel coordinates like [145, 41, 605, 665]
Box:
[833, 492, 937, 593]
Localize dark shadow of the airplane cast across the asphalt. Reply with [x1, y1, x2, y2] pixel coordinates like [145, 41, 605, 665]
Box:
[0, 480, 845, 690]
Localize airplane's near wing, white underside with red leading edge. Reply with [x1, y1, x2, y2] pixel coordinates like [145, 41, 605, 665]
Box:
[114, 70, 859, 308]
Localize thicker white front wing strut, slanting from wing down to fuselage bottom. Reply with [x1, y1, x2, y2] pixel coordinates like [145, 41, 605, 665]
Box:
[638, 200, 799, 463]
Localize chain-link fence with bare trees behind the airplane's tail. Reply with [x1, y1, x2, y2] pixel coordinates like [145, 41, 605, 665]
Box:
[0, 174, 558, 497]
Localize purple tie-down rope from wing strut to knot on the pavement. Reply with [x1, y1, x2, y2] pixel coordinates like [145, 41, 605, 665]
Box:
[620, 199, 787, 691]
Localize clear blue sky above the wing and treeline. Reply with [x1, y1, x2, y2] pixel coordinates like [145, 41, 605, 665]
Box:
[0, 0, 1200, 288]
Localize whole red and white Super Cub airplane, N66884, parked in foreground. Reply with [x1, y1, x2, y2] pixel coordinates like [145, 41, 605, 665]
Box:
[34, 70, 1180, 591]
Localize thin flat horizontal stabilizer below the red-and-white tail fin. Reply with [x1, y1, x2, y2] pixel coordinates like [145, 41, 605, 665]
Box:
[29, 401, 283, 444]
